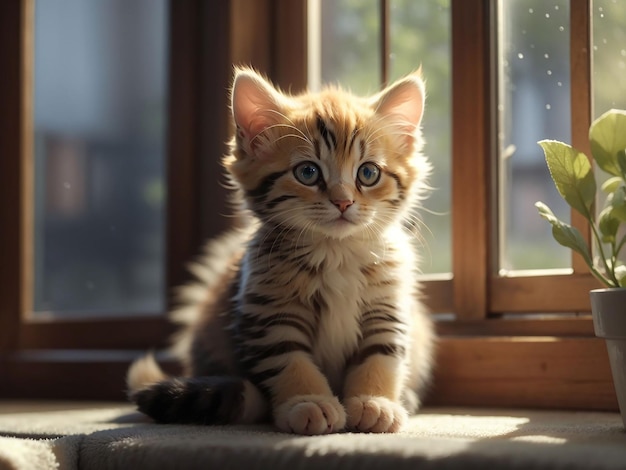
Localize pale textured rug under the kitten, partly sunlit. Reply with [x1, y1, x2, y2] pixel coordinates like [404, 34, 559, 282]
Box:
[0, 401, 626, 470]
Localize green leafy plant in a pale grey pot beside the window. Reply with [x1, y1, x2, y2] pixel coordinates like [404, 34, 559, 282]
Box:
[535, 109, 626, 427]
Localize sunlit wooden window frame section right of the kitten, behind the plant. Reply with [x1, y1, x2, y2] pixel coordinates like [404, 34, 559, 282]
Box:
[430, 0, 617, 410]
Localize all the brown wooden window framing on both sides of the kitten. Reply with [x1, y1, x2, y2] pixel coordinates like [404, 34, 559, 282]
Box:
[0, 0, 617, 410]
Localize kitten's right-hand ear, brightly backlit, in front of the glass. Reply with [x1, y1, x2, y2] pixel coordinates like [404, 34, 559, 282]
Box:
[373, 71, 426, 150]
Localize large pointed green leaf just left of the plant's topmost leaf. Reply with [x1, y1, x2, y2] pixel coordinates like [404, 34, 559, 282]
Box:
[539, 140, 596, 217]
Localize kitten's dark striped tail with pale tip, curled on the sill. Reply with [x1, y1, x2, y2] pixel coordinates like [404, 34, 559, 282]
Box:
[126, 355, 268, 424]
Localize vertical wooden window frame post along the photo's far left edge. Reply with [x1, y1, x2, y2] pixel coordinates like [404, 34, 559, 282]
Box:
[0, 0, 33, 352]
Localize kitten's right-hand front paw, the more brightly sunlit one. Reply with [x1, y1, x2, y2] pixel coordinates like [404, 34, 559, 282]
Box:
[344, 395, 407, 432]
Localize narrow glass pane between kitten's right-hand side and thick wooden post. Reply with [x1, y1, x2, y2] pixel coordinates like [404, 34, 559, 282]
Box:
[389, 0, 452, 273]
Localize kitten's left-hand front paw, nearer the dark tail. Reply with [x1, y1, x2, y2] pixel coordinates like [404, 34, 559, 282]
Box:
[274, 395, 346, 435]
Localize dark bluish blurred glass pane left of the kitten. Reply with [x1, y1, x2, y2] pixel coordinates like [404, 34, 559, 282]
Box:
[33, 0, 167, 315]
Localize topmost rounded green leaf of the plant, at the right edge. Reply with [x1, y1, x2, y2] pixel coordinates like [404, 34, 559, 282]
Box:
[589, 109, 626, 176]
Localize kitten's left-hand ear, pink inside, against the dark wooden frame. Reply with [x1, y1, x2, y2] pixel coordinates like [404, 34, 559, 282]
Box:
[231, 69, 282, 158]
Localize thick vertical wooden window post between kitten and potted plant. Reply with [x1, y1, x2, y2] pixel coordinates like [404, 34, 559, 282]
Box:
[451, 0, 492, 320]
